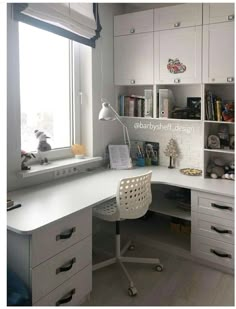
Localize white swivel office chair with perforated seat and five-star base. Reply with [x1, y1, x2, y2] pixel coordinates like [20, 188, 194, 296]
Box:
[93, 171, 163, 296]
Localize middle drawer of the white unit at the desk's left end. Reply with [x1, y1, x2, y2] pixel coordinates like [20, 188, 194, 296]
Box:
[32, 236, 92, 302]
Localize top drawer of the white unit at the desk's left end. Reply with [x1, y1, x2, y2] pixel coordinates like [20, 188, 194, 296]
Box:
[31, 208, 92, 268]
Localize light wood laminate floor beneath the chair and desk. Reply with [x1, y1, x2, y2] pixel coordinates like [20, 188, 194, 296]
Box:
[83, 217, 234, 306]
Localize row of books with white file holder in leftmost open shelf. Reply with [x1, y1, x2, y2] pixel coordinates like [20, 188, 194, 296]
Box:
[119, 89, 153, 117]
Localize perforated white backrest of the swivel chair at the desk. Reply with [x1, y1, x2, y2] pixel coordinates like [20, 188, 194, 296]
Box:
[116, 171, 152, 219]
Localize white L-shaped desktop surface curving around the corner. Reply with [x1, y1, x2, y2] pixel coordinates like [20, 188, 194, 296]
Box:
[7, 166, 234, 234]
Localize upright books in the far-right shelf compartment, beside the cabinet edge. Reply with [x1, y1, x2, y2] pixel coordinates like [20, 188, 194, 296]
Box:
[205, 91, 223, 121]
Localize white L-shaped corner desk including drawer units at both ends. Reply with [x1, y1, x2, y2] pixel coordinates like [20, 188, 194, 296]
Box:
[7, 167, 234, 305]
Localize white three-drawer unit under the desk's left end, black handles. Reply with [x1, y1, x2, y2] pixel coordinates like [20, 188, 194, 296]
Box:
[7, 209, 92, 306]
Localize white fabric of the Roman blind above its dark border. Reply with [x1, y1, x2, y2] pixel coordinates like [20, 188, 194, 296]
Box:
[21, 3, 97, 39]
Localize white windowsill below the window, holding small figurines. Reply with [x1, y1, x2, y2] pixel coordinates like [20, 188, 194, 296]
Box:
[18, 157, 103, 178]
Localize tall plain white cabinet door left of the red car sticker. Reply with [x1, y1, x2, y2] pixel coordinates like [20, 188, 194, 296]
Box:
[114, 32, 153, 85]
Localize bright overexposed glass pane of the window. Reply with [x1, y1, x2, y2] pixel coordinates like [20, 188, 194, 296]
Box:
[19, 23, 71, 151]
